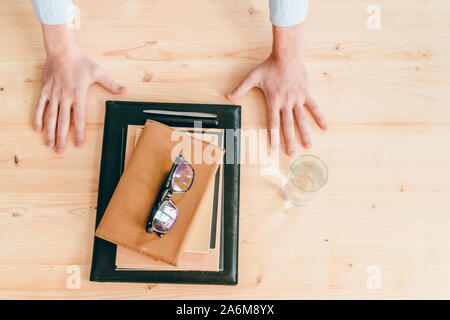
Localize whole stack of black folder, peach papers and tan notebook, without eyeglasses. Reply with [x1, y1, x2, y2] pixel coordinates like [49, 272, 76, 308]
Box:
[91, 101, 240, 284]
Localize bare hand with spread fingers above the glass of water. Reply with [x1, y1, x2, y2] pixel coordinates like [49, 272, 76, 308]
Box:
[226, 25, 328, 156]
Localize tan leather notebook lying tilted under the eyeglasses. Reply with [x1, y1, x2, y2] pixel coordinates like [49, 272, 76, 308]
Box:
[95, 120, 225, 266]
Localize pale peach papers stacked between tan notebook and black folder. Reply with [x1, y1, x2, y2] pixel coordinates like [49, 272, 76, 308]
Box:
[112, 125, 224, 271]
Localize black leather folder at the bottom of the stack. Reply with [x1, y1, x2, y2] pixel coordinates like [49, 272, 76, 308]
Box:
[90, 101, 241, 285]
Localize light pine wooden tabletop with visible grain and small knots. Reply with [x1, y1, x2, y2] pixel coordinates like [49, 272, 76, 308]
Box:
[0, 0, 450, 299]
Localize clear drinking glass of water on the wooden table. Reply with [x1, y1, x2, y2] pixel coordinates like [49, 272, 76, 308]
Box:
[282, 155, 328, 207]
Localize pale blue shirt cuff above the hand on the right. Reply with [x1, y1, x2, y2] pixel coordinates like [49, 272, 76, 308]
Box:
[269, 0, 309, 27]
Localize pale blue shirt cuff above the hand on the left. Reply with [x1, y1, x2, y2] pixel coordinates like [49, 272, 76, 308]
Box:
[31, 0, 75, 25]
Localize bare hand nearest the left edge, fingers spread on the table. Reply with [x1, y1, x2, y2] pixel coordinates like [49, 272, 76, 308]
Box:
[34, 25, 125, 152]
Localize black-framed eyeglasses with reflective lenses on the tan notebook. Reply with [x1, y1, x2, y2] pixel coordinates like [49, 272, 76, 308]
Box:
[145, 155, 194, 237]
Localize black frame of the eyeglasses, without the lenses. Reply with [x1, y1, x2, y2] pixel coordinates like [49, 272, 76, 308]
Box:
[145, 155, 195, 237]
